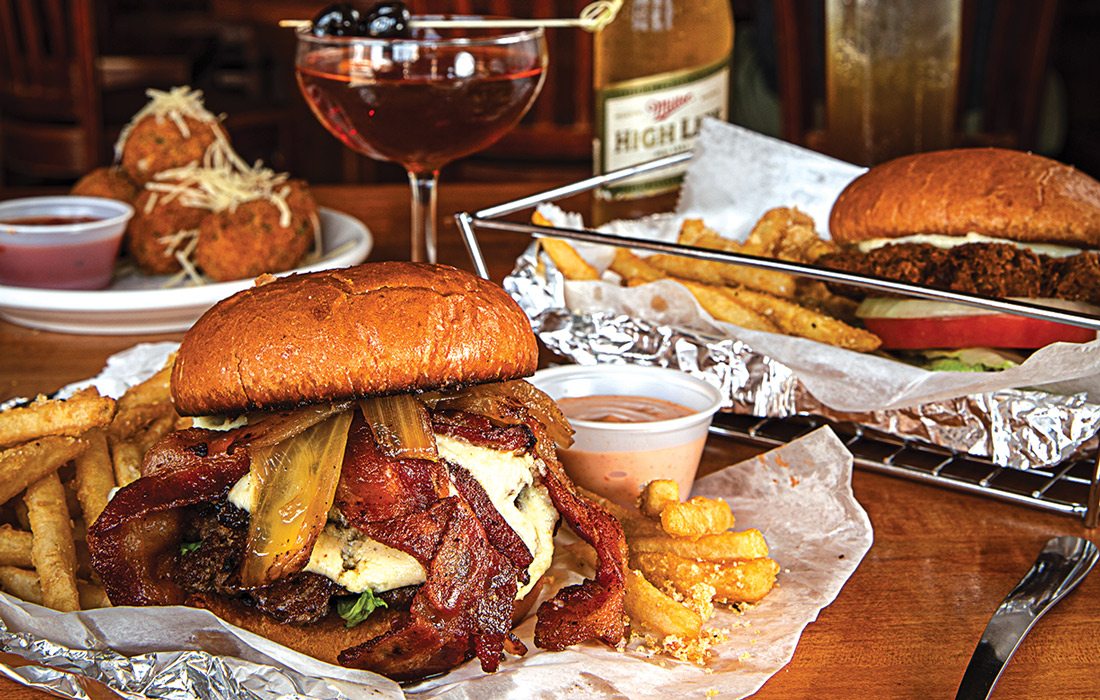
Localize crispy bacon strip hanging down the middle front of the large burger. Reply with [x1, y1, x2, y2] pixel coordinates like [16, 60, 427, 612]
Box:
[337, 409, 530, 679]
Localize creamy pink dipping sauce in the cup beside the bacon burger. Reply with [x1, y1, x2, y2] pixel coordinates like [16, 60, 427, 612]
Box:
[557, 395, 706, 505]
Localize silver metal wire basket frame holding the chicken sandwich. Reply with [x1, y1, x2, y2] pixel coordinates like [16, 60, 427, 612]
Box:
[454, 152, 1100, 528]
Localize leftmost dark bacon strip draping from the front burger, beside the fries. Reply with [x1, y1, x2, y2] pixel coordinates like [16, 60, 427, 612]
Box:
[88, 428, 249, 605]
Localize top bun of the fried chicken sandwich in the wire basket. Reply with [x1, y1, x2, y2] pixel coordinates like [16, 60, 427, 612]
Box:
[829, 149, 1100, 248]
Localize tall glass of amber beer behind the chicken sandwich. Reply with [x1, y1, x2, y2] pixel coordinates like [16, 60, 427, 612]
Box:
[825, 0, 963, 165]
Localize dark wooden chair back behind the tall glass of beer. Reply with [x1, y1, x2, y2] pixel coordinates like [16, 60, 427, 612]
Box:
[773, 0, 1058, 156]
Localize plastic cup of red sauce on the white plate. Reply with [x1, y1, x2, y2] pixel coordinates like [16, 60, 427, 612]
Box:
[0, 195, 134, 289]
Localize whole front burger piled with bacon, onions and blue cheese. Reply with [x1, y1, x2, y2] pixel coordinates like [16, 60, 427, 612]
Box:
[88, 263, 626, 680]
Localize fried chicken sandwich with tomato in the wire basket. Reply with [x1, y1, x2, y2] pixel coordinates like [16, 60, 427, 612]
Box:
[818, 149, 1100, 365]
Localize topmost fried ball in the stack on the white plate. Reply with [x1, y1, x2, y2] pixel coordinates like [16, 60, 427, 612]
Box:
[120, 114, 227, 185]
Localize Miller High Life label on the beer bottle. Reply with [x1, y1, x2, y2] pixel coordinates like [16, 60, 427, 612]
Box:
[593, 55, 729, 199]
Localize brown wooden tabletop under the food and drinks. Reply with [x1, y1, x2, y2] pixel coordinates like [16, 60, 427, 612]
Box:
[0, 182, 1100, 699]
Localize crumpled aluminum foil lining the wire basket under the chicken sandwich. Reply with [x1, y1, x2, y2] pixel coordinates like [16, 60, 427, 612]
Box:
[504, 245, 1100, 469]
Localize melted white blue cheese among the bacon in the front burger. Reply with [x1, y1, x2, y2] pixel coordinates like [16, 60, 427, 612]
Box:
[229, 435, 558, 599]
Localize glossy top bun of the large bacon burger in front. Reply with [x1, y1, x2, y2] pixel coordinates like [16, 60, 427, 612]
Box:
[172, 262, 538, 415]
